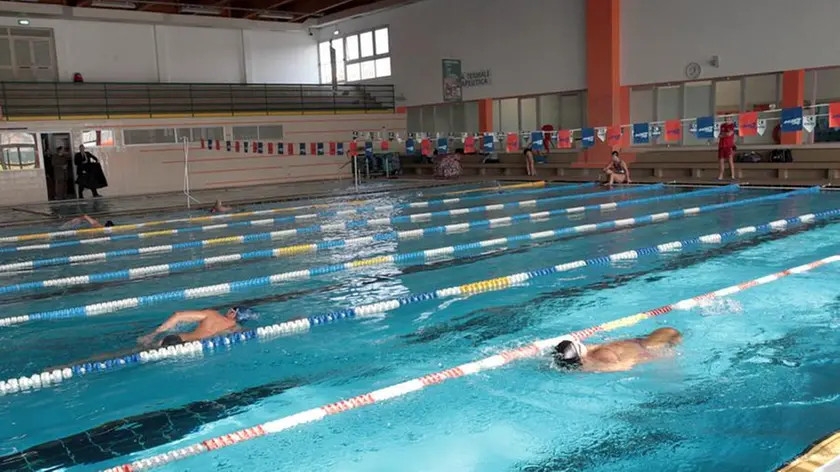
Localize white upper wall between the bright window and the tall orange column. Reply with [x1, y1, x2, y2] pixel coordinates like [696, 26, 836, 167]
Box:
[319, 0, 586, 106]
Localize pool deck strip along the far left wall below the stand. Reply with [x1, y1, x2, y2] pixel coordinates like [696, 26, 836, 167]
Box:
[0, 177, 492, 228]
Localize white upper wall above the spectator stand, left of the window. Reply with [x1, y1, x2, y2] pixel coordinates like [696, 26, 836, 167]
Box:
[0, 17, 318, 83]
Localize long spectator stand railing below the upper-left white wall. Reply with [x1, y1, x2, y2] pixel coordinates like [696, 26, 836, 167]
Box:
[0, 82, 395, 121]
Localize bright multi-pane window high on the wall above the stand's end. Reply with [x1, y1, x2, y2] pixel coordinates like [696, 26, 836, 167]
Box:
[318, 28, 391, 84]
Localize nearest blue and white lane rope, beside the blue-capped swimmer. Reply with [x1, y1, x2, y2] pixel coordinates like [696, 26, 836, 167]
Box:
[0, 209, 840, 394]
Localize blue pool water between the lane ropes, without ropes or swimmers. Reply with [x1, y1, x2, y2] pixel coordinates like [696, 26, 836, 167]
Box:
[0, 183, 840, 472]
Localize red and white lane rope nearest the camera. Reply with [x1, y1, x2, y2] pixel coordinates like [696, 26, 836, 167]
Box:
[100, 254, 840, 472]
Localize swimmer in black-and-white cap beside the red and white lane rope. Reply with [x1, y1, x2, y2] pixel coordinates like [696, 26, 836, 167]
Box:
[553, 328, 682, 372]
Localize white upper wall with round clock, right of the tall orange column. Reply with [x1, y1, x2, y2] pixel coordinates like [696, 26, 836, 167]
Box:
[621, 0, 840, 85]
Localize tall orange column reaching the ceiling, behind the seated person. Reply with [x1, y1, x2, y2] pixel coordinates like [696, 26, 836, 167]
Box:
[583, 0, 630, 166]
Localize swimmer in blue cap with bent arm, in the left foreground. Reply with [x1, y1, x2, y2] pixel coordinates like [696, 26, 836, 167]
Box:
[137, 306, 257, 347]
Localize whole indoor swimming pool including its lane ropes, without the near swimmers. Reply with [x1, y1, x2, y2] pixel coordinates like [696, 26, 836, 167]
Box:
[0, 183, 840, 472]
